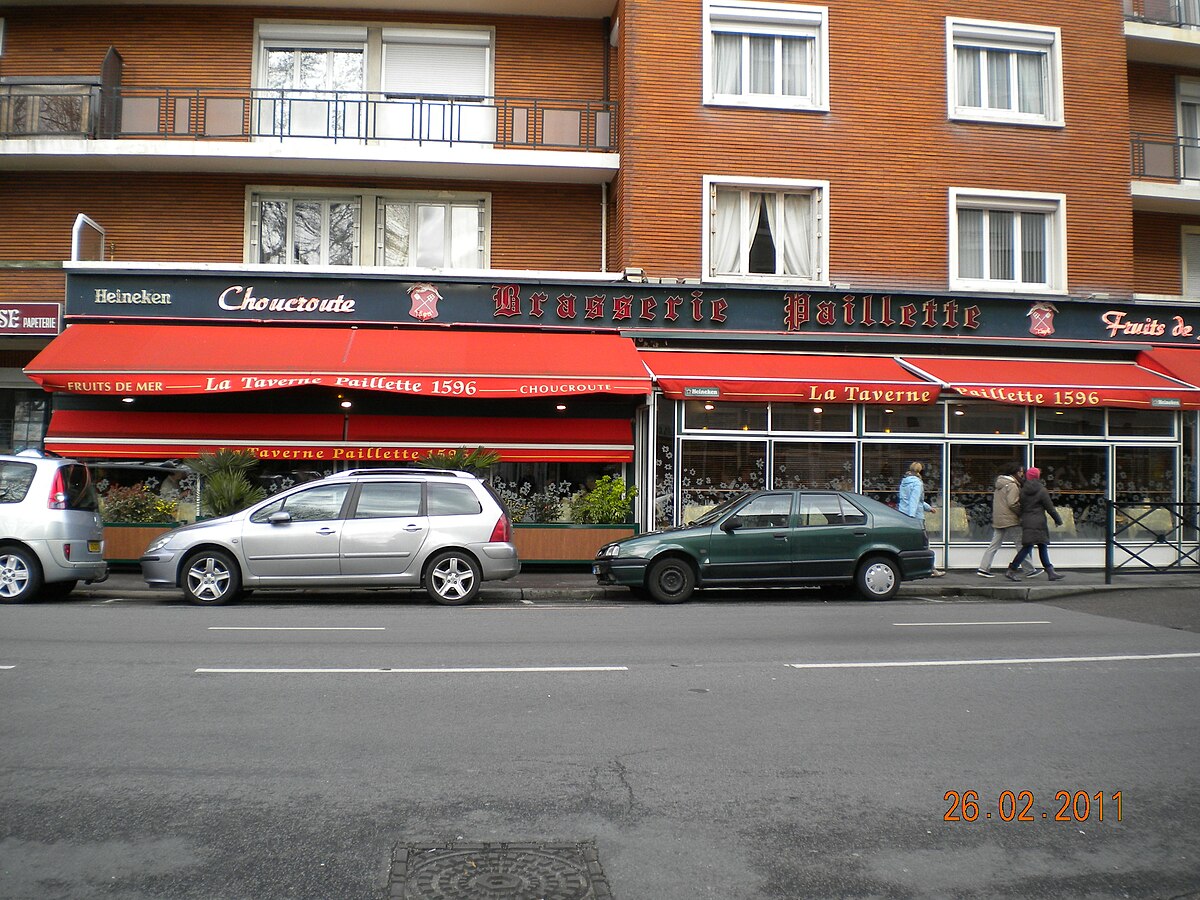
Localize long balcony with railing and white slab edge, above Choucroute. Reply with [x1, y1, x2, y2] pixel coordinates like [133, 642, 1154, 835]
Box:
[0, 79, 617, 182]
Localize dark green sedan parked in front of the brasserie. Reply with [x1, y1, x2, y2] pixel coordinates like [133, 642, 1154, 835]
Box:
[592, 491, 934, 604]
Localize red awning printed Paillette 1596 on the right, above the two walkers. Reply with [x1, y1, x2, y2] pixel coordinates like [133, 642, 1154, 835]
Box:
[904, 356, 1200, 409]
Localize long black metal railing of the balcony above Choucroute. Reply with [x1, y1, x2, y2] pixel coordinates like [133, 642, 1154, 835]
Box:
[0, 85, 616, 151]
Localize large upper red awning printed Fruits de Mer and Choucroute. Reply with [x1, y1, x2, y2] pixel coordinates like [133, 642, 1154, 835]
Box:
[25, 323, 650, 397]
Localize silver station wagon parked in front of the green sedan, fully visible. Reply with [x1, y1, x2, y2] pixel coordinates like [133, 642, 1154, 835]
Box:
[142, 469, 521, 606]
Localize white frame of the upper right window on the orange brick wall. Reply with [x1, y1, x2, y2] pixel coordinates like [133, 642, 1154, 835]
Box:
[946, 17, 1066, 127]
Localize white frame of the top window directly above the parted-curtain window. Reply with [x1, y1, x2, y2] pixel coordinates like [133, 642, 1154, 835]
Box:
[702, 0, 829, 112]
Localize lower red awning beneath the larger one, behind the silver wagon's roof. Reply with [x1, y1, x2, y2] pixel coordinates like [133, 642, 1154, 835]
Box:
[46, 409, 634, 463]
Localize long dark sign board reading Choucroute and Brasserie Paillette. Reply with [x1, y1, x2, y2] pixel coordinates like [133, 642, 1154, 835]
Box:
[65, 266, 1200, 344]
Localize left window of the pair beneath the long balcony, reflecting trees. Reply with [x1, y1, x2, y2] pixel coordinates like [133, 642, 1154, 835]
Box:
[252, 196, 360, 265]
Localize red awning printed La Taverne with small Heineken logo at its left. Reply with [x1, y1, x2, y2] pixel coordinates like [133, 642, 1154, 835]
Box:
[640, 350, 940, 404]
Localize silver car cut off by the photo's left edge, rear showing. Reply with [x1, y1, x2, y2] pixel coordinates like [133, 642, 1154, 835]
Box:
[0, 451, 108, 604]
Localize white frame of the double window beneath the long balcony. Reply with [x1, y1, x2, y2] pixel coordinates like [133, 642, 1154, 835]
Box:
[242, 185, 492, 272]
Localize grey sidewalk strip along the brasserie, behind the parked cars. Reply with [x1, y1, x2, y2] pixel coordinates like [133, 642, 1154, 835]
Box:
[72, 568, 1200, 604]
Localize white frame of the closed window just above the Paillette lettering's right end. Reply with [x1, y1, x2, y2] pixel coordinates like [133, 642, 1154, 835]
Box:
[949, 187, 1067, 294]
